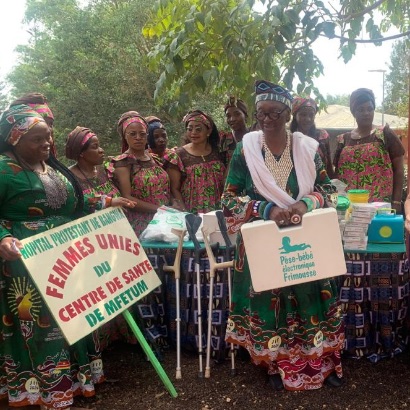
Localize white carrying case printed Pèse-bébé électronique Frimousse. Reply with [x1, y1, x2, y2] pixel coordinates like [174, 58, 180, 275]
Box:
[241, 208, 346, 292]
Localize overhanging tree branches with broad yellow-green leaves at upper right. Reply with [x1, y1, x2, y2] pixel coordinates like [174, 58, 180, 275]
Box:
[144, 0, 410, 111]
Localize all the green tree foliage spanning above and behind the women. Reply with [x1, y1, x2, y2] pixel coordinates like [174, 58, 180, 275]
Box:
[4, 0, 410, 154]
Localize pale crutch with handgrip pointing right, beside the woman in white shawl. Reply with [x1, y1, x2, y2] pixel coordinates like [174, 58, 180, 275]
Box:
[202, 227, 233, 378]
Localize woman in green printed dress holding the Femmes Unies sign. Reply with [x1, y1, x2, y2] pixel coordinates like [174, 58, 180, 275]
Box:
[0, 105, 104, 409]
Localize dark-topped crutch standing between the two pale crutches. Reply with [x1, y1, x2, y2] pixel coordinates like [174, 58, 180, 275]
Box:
[185, 214, 204, 378]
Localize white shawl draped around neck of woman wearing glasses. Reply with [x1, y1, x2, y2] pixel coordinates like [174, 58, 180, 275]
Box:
[243, 131, 319, 208]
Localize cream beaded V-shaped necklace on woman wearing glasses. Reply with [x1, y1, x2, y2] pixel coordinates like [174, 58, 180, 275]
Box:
[262, 134, 293, 191]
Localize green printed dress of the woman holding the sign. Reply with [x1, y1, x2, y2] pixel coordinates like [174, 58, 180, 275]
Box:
[0, 155, 104, 408]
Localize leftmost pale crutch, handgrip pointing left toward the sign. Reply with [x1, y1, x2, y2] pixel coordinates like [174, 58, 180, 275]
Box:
[162, 228, 186, 379]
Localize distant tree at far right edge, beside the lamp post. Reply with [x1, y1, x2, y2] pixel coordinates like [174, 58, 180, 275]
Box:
[384, 40, 410, 117]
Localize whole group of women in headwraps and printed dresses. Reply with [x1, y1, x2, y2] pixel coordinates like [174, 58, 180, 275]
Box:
[0, 80, 403, 409]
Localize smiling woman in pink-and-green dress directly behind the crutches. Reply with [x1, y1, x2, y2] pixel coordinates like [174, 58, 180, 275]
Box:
[164, 110, 225, 213]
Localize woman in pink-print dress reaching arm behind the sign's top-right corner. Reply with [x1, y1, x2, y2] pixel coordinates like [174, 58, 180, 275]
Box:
[107, 111, 170, 236]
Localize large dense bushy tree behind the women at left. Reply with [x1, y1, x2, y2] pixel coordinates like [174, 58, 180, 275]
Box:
[9, 0, 171, 153]
